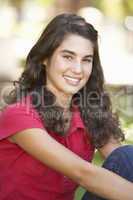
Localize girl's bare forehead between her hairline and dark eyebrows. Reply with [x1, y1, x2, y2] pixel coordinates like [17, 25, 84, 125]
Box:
[58, 34, 94, 55]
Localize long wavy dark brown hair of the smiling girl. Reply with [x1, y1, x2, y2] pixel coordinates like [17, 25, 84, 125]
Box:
[7, 13, 124, 148]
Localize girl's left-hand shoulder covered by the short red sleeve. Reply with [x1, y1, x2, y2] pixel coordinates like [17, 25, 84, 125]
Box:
[0, 98, 43, 139]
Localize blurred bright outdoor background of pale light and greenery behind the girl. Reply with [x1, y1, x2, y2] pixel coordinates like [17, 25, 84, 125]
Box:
[0, 0, 133, 200]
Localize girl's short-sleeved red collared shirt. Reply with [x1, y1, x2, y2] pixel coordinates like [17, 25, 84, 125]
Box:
[0, 98, 94, 200]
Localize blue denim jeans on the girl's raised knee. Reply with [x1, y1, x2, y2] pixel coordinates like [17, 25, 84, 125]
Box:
[82, 145, 133, 200]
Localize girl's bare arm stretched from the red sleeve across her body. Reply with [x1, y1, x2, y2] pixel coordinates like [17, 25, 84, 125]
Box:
[11, 129, 133, 200]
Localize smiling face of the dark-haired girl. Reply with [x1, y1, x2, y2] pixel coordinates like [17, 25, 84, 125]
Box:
[44, 34, 93, 101]
